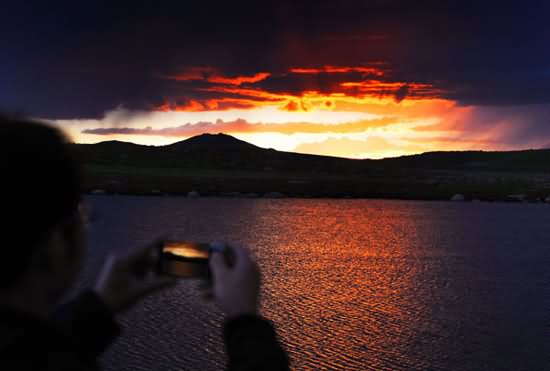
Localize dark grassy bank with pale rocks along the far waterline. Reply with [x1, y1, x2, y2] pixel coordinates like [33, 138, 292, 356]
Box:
[84, 165, 550, 200]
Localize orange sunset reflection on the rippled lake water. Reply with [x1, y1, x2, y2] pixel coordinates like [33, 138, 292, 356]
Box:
[239, 200, 442, 370]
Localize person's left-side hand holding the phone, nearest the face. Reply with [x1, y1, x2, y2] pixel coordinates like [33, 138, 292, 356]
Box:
[95, 240, 176, 313]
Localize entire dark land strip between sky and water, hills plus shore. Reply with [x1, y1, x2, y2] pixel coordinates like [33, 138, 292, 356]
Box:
[71, 134, 550, 199]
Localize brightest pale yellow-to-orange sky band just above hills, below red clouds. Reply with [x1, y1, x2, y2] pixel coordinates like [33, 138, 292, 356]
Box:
[55, 92, 470, 158]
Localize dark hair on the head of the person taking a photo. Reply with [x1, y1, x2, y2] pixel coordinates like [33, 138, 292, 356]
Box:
[0, 116, 80, 289]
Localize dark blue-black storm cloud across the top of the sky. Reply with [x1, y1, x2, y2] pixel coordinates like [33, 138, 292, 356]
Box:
[0, 1, 550, 118]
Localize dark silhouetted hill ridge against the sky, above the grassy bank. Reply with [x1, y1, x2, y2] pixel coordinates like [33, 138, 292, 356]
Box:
[73, 134, 550, 173]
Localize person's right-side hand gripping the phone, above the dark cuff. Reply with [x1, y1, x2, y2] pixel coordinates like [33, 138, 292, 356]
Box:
[209, 247, 260, 317]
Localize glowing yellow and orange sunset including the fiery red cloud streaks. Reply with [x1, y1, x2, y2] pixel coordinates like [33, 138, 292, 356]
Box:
[50, 61, 492, 158]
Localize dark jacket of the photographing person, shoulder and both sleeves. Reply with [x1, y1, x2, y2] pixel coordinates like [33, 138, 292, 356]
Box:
[0, 291, 288, 371]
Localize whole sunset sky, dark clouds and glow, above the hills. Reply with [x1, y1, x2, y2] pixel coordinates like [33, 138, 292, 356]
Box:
[0, 0, 550, 158]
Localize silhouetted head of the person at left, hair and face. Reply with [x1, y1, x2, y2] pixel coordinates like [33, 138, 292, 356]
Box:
[0, 116, 83, 308]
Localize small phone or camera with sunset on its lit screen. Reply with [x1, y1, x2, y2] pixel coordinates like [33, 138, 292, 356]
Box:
[157, 240, 230, 279]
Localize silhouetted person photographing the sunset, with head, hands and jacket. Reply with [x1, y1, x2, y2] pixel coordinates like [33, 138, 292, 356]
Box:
[0, 116, 289, 370]
